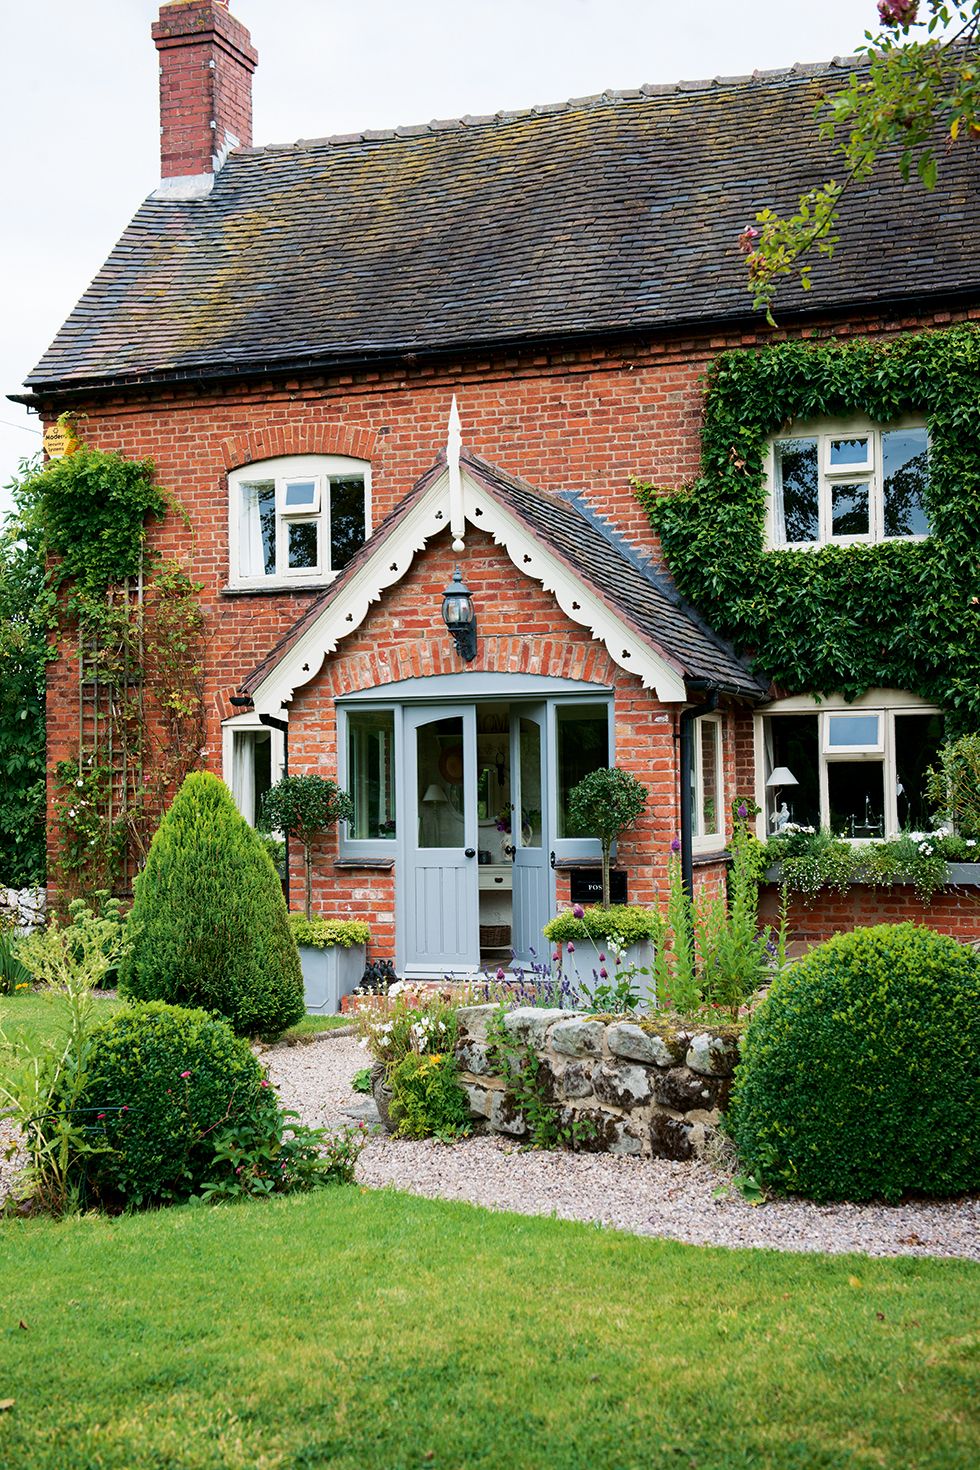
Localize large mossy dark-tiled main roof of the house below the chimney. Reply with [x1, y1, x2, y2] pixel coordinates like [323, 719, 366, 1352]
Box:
[21, 59, 980, 388]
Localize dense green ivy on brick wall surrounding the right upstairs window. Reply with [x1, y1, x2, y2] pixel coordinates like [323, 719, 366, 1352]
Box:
[638, 326, 980, 728]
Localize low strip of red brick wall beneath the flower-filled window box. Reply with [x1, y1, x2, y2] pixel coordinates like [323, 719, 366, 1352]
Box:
[760, 883, 980, 947]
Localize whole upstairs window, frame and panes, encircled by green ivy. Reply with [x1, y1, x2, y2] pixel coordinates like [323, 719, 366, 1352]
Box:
[770, 422, 929, 547]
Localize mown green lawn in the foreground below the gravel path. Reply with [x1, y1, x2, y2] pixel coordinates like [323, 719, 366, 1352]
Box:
[0, 1188, 980, 1470]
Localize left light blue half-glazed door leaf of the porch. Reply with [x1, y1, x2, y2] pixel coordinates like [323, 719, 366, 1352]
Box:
[400, 704, 480, 979]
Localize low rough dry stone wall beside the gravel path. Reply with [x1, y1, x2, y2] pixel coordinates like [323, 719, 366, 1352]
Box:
[455, 1005, 739, 1160]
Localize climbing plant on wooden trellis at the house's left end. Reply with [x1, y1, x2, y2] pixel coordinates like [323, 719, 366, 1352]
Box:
[13, 429, 204, 892]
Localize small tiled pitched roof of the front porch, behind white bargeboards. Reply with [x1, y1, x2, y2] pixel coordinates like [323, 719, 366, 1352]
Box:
[241, 451, 767, 700]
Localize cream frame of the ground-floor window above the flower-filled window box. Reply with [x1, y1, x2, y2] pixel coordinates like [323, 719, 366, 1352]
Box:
[755, 689, 943, 844]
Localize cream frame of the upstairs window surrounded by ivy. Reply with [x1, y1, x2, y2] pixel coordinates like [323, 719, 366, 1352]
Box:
[765, 416, 929, 551]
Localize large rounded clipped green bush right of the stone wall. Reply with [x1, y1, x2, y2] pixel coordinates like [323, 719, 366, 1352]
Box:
[727, 923, 980, 1200]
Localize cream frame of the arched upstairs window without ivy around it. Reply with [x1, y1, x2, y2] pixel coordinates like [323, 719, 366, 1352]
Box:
[228, 454, 372, 588]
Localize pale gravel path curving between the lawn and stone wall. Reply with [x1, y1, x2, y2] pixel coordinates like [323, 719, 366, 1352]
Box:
[263, 1036, 980, 1261]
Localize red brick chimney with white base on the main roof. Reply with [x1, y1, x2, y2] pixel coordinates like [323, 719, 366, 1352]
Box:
[153, 0, 259, 198]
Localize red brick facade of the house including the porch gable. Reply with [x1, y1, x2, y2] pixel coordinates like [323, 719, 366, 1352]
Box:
[36, 312, 980, 946]
